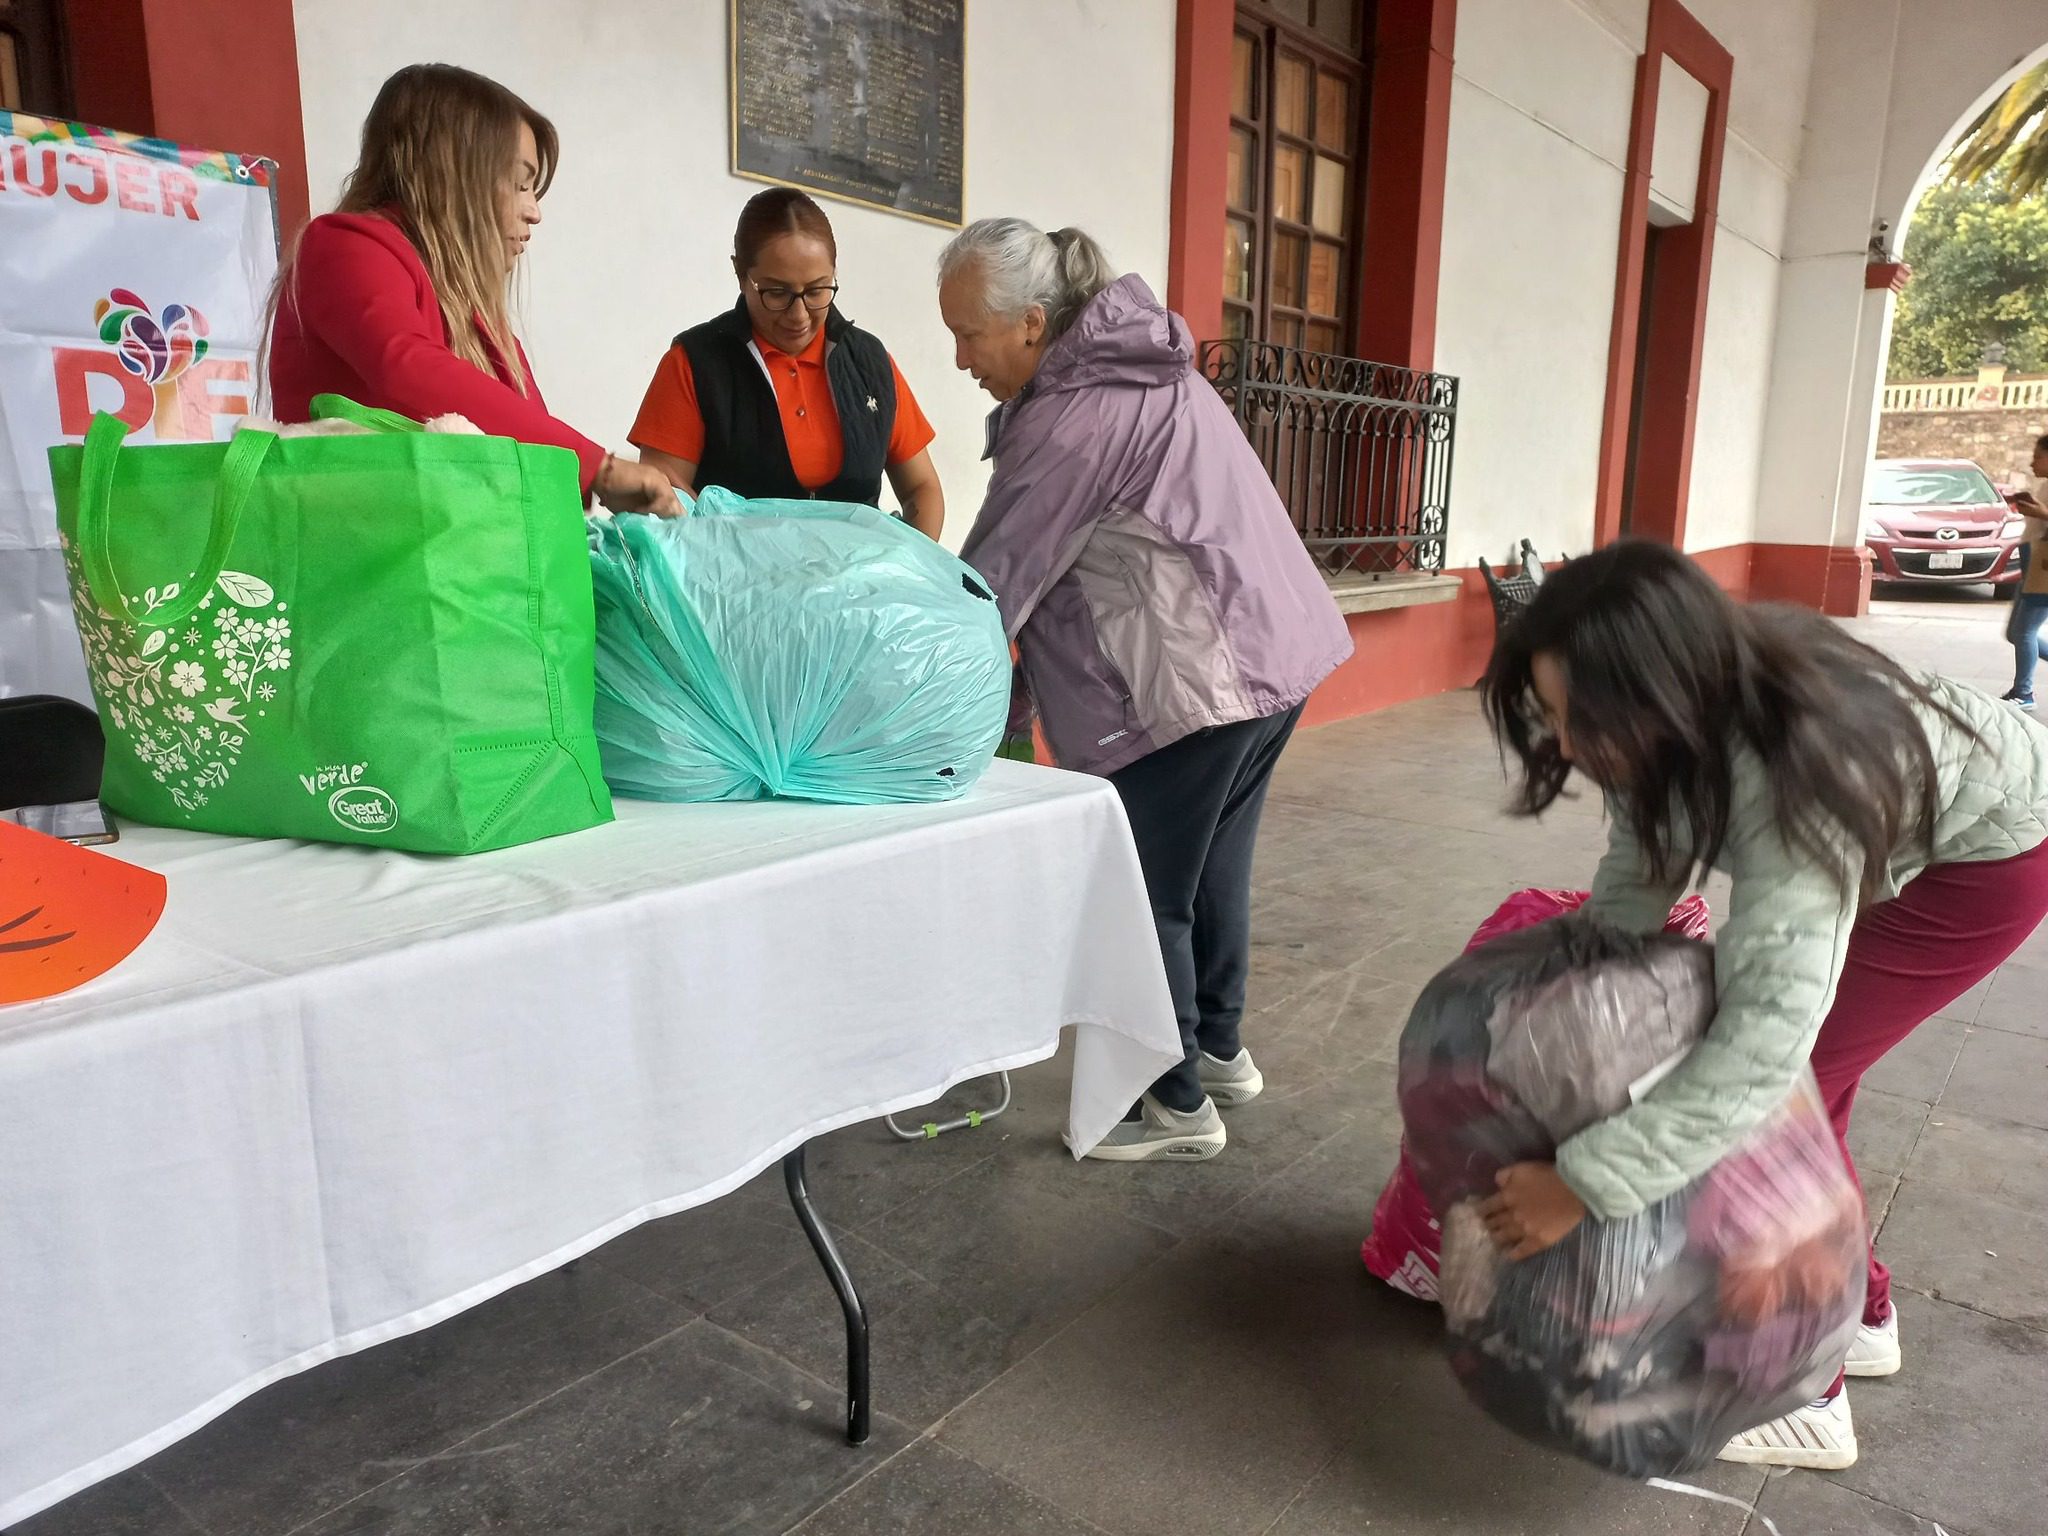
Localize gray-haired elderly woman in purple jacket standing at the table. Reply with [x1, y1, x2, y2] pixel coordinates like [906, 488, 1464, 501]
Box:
[938, 219, 1352, 1161]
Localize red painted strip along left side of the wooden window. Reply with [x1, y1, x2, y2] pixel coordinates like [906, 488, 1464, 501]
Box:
[1165, 0, 1237, 342]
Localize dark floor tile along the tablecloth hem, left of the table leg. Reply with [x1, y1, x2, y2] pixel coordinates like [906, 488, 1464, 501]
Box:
[147, 1262, 688, 1536]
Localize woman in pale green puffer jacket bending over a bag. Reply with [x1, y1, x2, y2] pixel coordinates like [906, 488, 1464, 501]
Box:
[1485, 543, 2048, 1468]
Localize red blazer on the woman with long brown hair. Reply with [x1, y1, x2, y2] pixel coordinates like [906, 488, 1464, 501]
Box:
[293, 219, 604, 492]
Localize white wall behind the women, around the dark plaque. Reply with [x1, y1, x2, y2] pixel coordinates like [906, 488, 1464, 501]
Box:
[293, 0, 1174, 543]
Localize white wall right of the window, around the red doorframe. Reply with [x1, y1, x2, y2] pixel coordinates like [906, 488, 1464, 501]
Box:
[1438, 0, 1817, 565]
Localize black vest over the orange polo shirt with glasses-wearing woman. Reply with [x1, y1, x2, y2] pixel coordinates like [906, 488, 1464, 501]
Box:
[676, 299, 895, 506]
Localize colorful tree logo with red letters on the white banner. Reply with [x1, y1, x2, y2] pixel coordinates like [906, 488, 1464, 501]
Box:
[51, 289, 250, 442]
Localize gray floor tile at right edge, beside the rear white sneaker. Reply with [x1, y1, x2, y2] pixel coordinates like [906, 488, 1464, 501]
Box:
[1878, 1178, 2048, 1329]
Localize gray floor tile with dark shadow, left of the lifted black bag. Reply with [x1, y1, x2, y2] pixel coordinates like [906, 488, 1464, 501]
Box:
[940, 1126, 1425, 1536]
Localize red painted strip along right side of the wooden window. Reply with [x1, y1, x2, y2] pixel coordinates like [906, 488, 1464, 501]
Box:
[1354, 0, 1458, 371]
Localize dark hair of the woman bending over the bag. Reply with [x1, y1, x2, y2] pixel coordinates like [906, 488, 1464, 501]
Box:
[1481, 541, 1970, 899]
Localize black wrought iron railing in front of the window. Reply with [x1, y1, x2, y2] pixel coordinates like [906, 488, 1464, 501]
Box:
[1202, 340, 1458, 575]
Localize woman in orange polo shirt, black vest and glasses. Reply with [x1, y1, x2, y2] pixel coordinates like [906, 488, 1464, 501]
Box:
[631, 186, 946, 539]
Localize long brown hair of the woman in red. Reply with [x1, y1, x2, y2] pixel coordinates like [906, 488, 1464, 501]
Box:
[266, 63, 561, 393]
